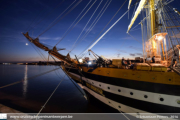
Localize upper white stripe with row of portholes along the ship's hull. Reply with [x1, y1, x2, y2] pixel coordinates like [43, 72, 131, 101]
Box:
[69, 72, 180, 107]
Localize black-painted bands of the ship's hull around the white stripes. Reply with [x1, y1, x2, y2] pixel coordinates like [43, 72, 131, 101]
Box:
[63, 68, 180, 113]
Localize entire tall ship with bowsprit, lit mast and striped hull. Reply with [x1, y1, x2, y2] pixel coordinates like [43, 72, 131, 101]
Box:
[23, 0, 180, 116]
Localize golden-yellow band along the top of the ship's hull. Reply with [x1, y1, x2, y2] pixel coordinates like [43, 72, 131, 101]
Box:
[82, 67, 180, 85]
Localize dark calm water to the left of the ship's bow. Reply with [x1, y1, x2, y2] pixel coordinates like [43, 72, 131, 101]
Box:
[0, 65, 118, 113]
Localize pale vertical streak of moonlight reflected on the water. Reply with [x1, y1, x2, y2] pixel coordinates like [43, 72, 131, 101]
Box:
[23, 65, 28, 97]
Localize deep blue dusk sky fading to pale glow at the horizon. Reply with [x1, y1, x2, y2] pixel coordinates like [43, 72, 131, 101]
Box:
[0, 0, 179, 62]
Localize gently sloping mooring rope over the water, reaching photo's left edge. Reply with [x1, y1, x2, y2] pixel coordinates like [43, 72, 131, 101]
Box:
[0, 68, 59, 89]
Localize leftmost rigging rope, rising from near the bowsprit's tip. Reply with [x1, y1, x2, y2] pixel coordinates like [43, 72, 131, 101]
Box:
[38, 0, 82, 37]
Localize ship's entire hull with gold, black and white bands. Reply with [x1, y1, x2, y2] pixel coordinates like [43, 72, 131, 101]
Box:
[63, 66, 180, 113]
